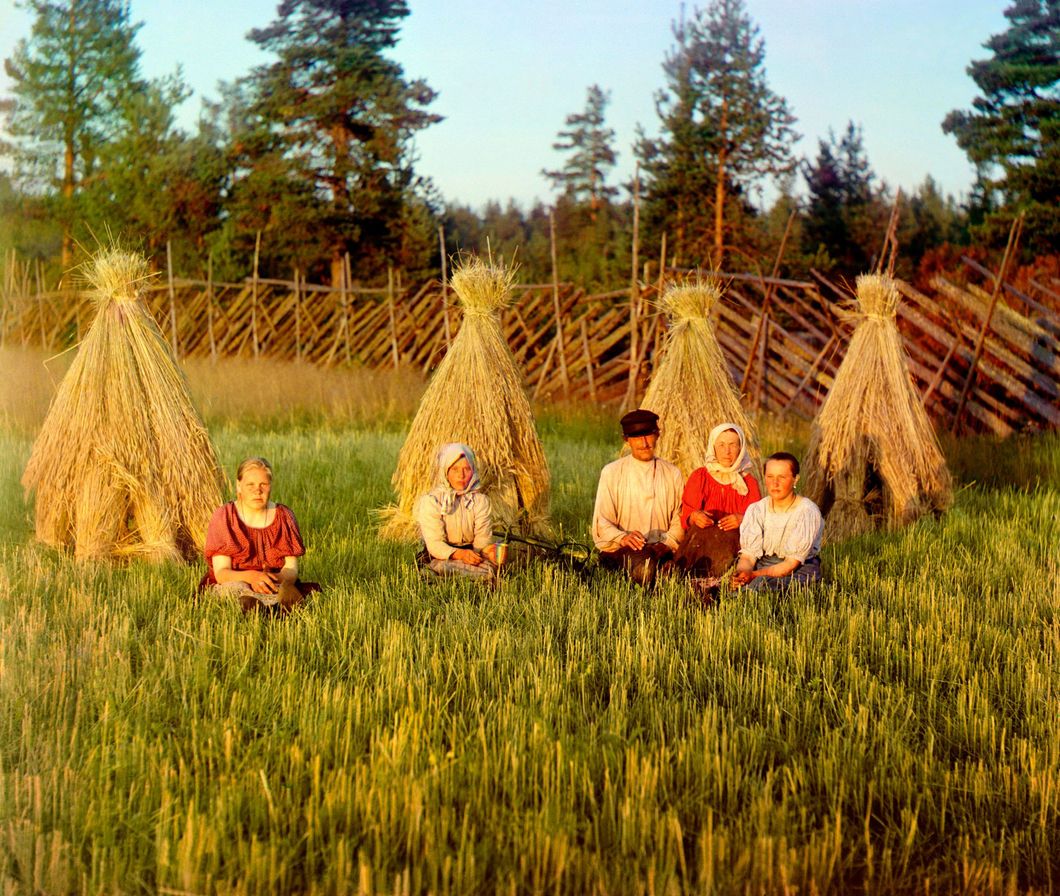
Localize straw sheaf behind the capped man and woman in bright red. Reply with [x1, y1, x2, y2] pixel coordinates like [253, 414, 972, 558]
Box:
[641, 279, 759, 478]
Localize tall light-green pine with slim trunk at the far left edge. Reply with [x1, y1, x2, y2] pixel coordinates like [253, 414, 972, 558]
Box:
[4, 0, 145, 269]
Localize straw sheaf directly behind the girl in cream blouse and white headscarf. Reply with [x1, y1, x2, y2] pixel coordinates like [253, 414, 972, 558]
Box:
[381, 258, 549, 541]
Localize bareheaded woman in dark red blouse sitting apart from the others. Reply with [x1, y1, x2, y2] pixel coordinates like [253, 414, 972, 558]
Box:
[202, 457, 319, 612]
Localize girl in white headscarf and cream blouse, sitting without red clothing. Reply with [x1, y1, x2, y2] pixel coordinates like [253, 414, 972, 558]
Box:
[414, 442, 496, 578]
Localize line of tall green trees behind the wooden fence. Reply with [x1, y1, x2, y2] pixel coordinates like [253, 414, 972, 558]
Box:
[0, 0, 1060, 287]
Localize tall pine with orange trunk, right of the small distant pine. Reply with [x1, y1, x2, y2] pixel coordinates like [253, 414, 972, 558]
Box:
[638, 0, 796, 265]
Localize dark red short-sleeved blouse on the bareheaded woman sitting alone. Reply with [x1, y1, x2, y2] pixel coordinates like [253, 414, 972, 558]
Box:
[206, 502, 305, 584]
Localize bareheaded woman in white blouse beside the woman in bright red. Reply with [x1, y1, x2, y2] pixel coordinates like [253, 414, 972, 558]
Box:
[732, 452, 825, 591]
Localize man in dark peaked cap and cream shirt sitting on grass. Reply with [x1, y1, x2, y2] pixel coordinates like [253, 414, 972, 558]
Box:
[593, 408, 685, 585]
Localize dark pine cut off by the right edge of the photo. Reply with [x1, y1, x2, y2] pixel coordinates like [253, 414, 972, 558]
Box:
[942, 0, 1060, 252]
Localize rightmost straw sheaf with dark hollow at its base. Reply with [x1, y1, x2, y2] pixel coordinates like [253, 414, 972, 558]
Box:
[803, 275, 953, 541]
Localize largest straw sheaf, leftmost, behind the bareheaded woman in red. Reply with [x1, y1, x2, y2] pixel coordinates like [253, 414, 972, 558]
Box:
[22, 249, 224, 560]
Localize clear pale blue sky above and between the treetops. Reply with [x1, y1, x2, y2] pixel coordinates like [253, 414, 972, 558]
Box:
[0, 0, 1010, 207]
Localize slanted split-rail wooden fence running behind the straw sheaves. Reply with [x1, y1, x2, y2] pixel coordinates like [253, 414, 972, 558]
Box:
[0, 253, 1060, 436]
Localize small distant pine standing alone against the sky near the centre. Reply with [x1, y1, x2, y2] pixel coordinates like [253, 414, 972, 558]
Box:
[542, 84, 618, 221]
